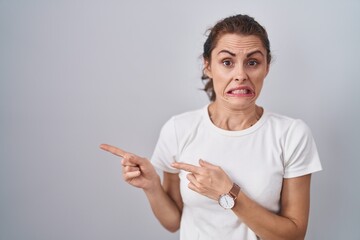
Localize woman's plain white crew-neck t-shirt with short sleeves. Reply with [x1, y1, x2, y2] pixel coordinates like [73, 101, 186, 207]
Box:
[151, 106, 321, 240]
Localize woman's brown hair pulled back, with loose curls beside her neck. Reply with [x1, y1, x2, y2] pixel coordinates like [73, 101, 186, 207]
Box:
[201, 14, 271, 101]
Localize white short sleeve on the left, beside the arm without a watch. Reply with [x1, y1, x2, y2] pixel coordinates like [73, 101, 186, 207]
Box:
[151, 117, 179, 173]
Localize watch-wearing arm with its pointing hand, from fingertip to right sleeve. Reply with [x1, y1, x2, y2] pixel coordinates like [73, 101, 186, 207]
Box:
[173, 160, 311, 240]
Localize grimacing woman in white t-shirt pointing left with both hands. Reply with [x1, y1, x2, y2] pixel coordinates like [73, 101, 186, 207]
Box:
[101, 15, 321, 240]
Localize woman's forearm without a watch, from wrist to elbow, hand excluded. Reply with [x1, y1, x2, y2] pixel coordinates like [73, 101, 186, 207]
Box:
[144, 179, 181, 232]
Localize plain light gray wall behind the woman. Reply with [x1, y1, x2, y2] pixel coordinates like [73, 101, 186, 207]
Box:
[0, 0, 360, 240]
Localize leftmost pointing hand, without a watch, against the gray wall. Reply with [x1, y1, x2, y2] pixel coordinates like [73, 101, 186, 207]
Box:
[100, 144, 160, 191]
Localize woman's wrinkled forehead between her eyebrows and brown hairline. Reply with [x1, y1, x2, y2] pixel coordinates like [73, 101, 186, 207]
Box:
[213, 33, 265, 54]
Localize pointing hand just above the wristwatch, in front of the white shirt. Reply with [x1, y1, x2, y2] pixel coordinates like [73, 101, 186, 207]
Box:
[172, 159, 233, 201]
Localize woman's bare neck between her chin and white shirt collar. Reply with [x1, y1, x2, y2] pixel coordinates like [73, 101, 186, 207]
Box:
[208, 102, 263, 131]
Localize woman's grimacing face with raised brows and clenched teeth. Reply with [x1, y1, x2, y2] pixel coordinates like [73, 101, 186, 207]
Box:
[205, 34, 269, 109]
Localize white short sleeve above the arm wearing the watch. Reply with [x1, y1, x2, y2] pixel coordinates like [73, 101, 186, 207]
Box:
[284, 120, 322, 178]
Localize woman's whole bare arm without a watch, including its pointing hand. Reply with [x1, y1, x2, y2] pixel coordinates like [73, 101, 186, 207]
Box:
[100, 144, 182, 232]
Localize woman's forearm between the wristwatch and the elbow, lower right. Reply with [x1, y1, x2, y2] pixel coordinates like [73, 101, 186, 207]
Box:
[233, 192, 307, 240]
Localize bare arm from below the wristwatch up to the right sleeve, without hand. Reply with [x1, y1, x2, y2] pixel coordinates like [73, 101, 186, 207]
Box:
[233, 175, 311, 240]
